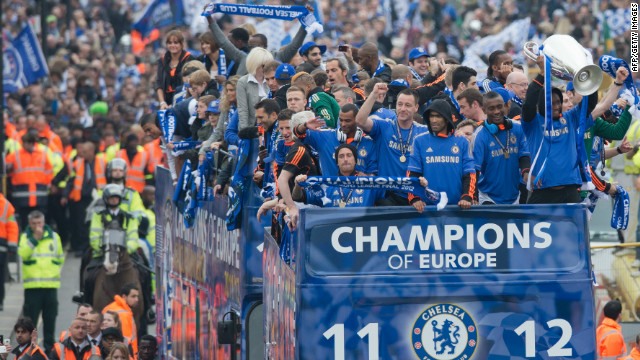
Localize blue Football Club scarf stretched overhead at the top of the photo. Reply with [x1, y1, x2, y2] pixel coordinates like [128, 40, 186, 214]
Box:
[202, 4, 324, 33]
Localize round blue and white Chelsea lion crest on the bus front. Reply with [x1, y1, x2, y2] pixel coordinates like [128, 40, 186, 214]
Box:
[411, 304, 478, 360]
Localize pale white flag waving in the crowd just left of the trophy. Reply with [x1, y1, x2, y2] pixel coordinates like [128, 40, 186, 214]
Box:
[462, 18, 531, 69]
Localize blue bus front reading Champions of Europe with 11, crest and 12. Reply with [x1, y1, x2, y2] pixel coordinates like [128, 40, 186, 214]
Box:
[265, 205, 596, 360]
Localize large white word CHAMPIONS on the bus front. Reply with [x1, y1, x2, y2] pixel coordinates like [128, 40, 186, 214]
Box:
[331, 221, 552, 254]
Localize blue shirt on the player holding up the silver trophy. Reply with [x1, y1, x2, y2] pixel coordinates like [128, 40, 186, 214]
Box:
[522, 106, 593, 189]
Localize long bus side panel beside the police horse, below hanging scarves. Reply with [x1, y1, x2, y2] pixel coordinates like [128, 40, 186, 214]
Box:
[156, 168, 244, 359]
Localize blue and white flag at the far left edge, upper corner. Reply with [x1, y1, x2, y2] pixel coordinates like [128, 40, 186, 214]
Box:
[2, 25, 49, 93]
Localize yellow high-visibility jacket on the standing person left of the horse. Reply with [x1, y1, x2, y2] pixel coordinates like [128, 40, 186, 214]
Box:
[18, 225, 64, 289]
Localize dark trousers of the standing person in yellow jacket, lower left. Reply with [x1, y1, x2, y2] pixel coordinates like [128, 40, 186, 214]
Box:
[22, 289, 58, 352]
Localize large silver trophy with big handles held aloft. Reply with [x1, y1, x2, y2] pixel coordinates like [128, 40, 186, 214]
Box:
[523, 35, 603, 96]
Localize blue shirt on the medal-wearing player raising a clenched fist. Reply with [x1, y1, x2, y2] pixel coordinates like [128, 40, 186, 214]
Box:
[369, 111, 429, 179]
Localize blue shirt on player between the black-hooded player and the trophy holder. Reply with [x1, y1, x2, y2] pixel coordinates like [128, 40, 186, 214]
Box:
[473, 122, 530, 204]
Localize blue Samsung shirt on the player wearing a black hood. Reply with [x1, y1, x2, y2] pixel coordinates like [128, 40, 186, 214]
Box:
[408, 133, 476, 204]
